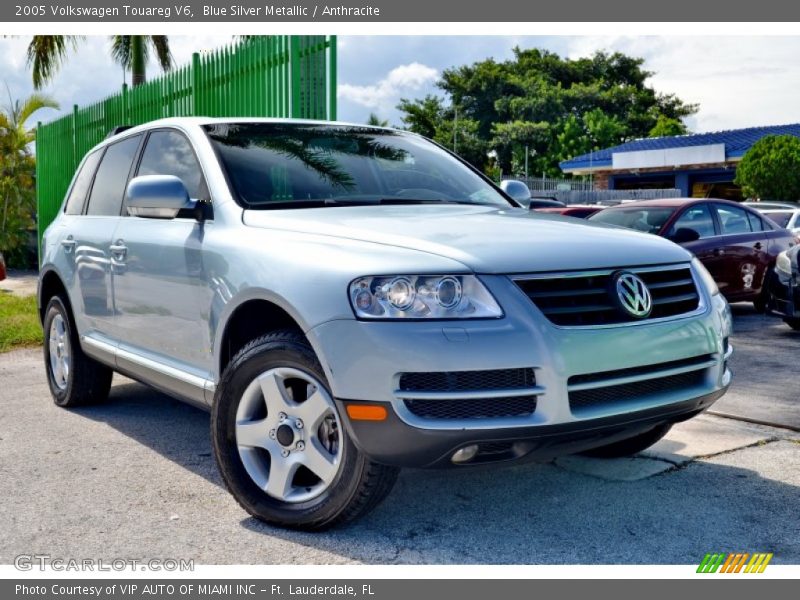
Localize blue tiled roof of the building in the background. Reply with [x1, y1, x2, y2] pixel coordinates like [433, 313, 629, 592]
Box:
[560, 123, 800, 172]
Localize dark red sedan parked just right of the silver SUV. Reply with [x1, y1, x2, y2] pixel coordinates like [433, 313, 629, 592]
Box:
[589, 198, 797, 310]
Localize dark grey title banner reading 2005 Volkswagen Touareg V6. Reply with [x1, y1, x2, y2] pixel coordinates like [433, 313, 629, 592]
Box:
[0, 0, 800, 21]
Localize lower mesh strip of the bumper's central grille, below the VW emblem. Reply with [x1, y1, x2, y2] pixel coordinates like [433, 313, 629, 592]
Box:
[569, 369, 706, 413]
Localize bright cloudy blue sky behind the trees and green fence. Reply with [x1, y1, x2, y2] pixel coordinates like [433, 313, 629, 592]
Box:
[0, 35, 800, 137]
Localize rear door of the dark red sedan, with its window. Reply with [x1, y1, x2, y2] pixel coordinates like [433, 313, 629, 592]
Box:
[713, 202, 769, 300]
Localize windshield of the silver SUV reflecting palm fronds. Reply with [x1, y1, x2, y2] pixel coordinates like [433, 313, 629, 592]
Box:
[205, 123, 510, 209]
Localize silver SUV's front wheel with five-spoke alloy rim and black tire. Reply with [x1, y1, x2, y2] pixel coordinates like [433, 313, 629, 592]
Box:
[211, 330, 399, 531]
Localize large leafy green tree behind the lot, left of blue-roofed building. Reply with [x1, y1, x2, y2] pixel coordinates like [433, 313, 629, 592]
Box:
[398, 48, 697, 175]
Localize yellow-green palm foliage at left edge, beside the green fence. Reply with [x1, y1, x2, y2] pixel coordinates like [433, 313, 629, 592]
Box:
[0, 94, 58, 266]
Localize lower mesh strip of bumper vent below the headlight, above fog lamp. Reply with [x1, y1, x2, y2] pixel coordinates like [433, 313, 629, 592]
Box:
[405, 396, 536, 420]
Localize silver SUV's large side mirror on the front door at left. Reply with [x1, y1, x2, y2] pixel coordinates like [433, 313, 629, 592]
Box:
[125, 175, 193, 219]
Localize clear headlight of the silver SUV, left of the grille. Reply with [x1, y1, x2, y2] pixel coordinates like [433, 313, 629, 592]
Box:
[350, 275, 503, 319]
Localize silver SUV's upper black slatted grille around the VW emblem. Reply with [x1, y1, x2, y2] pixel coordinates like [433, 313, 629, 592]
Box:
[515, 266, 700, 326]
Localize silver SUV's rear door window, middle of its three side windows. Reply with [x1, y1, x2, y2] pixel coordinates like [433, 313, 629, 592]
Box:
[86, 135, 142, 216]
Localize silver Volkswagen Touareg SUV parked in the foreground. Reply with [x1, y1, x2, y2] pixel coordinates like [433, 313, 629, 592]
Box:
[39, 118, 731, 529]
